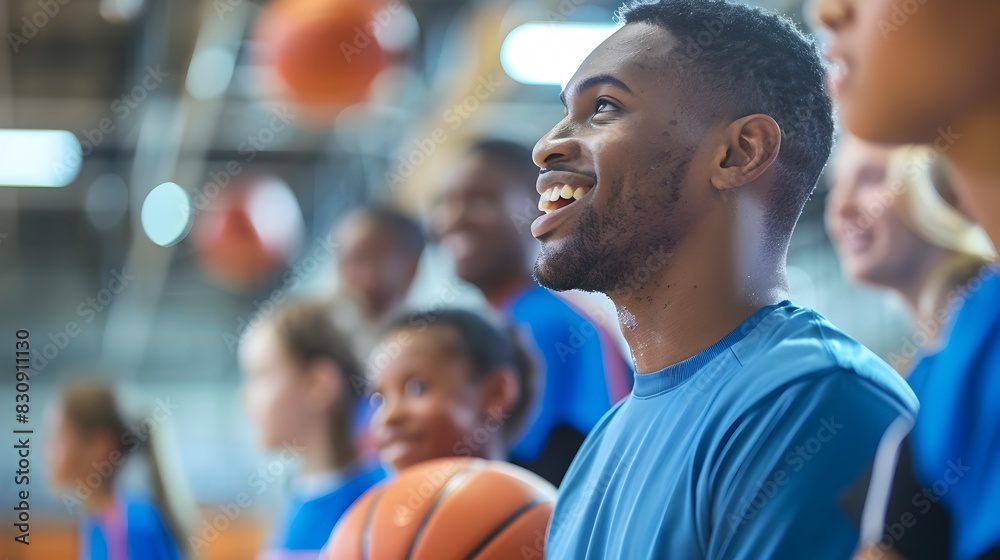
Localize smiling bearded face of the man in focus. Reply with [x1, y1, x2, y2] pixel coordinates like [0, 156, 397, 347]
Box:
[531, 23, 719, 294]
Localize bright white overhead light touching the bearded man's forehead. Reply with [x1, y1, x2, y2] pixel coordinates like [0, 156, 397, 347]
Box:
[500, 22, 618, 86]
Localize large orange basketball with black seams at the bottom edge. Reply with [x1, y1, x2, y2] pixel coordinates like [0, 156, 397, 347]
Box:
[324, 457, 556, 560]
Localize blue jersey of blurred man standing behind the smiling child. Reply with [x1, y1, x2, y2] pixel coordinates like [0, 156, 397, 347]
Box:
[501, 284, 632, 485]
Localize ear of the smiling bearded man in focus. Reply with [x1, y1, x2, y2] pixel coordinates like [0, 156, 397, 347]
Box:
[711, 114, 781, 191]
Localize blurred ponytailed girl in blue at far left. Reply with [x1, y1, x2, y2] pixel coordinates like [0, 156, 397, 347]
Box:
[45, 382, 192, 560]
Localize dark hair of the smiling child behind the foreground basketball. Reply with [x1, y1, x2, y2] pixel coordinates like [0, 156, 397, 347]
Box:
[379, 307, 537, 444]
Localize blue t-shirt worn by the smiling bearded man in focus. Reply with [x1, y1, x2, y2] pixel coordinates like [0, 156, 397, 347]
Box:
[546, 301, 917, 560]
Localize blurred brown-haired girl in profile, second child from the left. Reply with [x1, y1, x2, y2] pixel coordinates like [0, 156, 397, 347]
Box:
[239, 302, 385, 559]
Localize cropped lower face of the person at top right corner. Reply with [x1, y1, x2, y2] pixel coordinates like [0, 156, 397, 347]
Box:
[812, 0, 1000, 144]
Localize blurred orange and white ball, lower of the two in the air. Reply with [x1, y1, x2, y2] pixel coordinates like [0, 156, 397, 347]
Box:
[191, 176, 305, 289]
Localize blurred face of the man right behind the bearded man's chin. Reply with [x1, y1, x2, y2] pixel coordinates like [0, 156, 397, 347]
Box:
[432, 155, 538, 287]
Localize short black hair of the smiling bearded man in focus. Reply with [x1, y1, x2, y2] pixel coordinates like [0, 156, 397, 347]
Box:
[617, 0, 835, 235]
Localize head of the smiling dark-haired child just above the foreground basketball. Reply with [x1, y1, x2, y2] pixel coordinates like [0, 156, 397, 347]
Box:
[369, 309, 534, 471]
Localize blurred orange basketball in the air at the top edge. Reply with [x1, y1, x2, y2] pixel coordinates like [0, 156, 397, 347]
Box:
[255, 0, 389, 111]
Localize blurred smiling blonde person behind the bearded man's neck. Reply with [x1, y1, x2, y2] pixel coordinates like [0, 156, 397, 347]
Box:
[826, 136, 994, 373]
